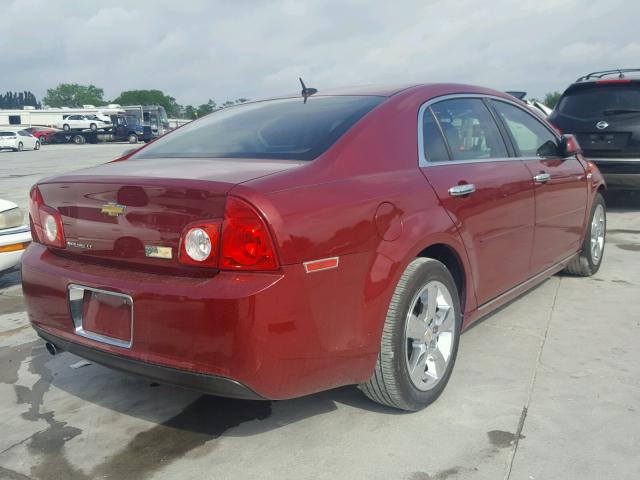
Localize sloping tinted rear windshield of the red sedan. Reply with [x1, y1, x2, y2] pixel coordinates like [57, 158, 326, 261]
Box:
[133, 96, 384, 160]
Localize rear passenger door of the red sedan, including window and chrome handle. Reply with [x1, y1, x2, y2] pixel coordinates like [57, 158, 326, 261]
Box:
[418, 96, 534, 304]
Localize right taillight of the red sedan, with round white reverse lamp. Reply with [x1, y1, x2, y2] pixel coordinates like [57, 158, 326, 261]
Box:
[179, 197, 278, 271]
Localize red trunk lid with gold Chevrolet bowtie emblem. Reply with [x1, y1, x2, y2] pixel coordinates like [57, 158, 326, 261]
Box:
[38, 158, 299, 269]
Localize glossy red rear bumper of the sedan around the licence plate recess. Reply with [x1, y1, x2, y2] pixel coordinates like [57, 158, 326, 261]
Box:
[22, 243, 379, 399]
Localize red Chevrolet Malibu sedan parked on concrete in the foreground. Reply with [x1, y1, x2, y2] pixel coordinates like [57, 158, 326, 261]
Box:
[22, 84, 605, 410]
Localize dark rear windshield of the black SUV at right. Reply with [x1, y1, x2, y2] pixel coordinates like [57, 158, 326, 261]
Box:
[557, 84, 640, 118]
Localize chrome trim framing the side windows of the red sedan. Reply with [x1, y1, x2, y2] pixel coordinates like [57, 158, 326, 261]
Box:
[418, 93, 560, 168]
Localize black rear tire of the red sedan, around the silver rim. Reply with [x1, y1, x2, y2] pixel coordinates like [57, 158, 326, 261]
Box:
[359, 258, 462, 411]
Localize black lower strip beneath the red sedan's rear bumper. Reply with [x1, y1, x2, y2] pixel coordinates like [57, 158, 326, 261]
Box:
[34, 326, 264, 400]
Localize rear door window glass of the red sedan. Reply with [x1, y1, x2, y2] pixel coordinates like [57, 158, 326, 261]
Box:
[431, 98, 508, 160]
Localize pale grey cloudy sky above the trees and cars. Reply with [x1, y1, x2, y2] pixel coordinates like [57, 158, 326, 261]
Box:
[0, 0, 640, 105]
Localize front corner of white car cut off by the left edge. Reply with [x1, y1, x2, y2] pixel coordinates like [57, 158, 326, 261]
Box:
[0, 199, 31, 275]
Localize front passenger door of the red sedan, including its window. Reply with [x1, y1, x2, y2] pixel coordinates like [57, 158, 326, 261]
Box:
[492, 100, 587, 274]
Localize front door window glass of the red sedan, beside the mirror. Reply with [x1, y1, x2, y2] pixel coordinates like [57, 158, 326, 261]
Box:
[492, 100, 560, 158]
